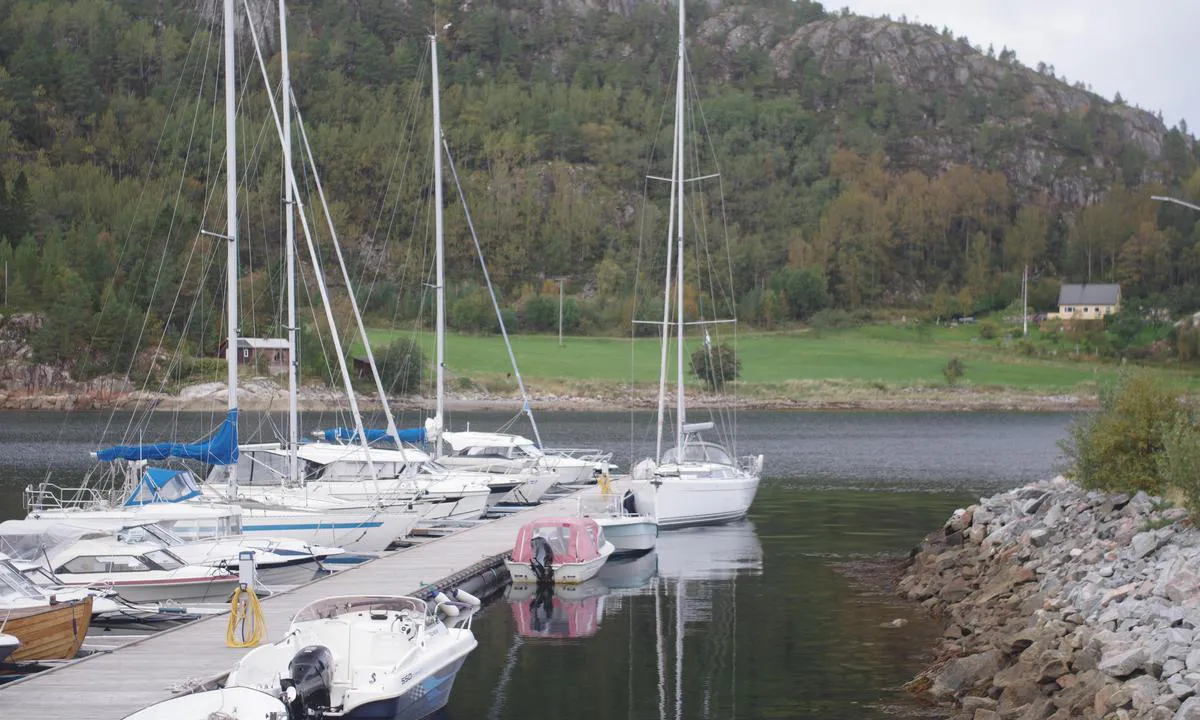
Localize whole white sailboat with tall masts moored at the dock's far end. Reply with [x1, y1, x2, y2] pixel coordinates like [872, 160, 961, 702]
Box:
[634, 0, 762, 529]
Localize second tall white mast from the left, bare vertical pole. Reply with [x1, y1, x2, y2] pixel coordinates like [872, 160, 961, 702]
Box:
[280, 0, 300, 482]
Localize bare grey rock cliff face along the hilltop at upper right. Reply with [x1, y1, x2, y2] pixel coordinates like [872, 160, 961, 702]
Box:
[697, 8, 1168, 205]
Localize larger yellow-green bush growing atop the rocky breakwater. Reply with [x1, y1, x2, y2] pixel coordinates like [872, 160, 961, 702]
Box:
[1060, 371, 1187, 494]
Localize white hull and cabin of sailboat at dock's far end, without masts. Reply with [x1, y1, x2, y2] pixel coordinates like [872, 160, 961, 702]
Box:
[632, 422, 762, 529]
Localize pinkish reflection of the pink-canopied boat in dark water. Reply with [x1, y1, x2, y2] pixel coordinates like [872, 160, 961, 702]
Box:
[508, 578, 608, 640]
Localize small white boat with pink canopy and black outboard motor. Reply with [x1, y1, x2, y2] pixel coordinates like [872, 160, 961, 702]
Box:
[504, 517, 614, 584]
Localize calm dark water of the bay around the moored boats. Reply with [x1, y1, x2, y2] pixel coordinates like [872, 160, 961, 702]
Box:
[0, 413, 1072, 720]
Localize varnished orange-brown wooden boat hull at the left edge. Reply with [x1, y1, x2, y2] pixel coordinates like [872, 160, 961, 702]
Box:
[0, 595, 91, 662]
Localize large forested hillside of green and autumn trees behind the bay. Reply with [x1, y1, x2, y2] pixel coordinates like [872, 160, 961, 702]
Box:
[0, 0, 1200, 381]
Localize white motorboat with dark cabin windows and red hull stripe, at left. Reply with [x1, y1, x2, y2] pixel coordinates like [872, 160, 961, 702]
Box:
[0, 520, 238, 602]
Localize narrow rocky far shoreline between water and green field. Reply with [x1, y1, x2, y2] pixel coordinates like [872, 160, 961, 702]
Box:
[0, 378, 1098, 413]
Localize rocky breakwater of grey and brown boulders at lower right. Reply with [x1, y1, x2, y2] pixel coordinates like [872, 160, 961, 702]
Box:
[899, 478, 1200, 720]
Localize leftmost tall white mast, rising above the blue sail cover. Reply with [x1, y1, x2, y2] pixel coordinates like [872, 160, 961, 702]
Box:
[224, 0, 238, 493]
